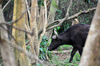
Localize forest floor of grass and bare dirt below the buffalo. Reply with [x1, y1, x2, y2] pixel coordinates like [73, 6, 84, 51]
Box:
[48, 47, 80, 66]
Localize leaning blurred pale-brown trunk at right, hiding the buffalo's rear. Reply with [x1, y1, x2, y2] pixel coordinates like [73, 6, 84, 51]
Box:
[79, 0, 100, 66]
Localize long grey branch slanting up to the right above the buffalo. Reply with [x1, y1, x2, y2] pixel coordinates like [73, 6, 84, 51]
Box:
[38, 7, 96, 35]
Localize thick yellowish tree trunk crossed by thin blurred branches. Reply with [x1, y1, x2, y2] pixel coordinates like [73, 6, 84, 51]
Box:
[12, 0, 29, 66]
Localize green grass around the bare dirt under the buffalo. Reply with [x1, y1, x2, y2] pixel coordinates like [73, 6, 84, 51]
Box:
[50, 45, 80, 66]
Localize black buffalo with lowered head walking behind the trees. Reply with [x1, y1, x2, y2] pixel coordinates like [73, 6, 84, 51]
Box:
[48, 24, 90, 62]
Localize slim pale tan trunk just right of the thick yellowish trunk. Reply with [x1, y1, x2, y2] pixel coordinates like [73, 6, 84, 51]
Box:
[30, 0, 39, 63]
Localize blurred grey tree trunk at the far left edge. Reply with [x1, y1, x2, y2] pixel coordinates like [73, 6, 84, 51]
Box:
[0, 4, 15, 66]
